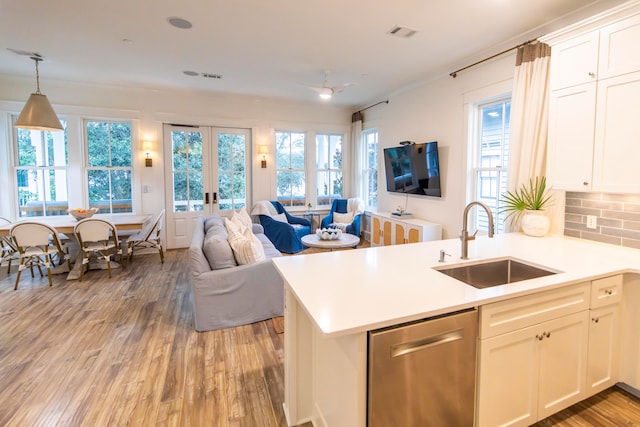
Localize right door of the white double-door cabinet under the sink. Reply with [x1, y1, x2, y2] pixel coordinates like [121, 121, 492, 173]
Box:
[538, 310, 589, 420]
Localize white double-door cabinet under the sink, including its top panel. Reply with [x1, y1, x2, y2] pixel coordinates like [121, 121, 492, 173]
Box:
[476, 283, 589, 427]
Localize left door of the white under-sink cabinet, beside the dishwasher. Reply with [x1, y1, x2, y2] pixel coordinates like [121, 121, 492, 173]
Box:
[476, 326, 542, 427]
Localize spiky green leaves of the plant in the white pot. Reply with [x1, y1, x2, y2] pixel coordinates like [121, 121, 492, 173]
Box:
[500, 176, 552, 224]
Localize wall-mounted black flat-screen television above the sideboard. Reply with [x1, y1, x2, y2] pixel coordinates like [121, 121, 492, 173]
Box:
[384, 141, 442, 197]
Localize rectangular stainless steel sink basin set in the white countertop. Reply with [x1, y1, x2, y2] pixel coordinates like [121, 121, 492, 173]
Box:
[434, 257, 557, 289]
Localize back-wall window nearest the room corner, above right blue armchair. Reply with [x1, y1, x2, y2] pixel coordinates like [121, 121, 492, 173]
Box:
[316, 134, 343, 206]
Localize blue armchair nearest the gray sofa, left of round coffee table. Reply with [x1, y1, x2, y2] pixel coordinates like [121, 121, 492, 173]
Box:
[258, 201, 311, 254]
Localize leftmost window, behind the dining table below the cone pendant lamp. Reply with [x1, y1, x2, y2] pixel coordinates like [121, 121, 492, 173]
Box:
[15, 121, 69, 217]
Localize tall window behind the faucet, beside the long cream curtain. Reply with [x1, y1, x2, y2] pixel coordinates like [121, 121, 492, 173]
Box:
[472, 98, 511, 233]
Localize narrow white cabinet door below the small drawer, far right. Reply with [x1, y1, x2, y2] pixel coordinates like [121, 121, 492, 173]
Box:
[587, 304, 620, 397]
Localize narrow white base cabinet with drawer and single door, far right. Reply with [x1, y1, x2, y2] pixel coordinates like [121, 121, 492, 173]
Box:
[587, 275, 623, 396]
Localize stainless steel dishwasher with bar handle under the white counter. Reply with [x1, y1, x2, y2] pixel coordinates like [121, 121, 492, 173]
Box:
[367, 309, 478, 427]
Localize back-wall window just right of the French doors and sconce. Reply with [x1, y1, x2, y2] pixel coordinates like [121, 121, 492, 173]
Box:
[276, 131, 306, 206]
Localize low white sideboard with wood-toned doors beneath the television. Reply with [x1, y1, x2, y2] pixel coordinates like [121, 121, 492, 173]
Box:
[371, 212, 442, 246]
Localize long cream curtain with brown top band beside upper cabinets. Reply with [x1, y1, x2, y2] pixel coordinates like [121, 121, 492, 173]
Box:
[509, 43, 551, 189]
